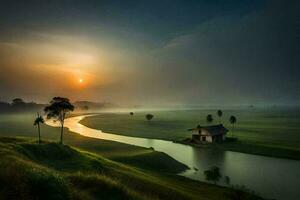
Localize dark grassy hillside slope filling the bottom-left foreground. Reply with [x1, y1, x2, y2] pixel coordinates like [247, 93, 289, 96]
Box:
[0, 137, 259, 200]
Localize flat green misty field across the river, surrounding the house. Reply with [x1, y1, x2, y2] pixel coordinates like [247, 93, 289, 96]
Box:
[81, 108, 300, 159]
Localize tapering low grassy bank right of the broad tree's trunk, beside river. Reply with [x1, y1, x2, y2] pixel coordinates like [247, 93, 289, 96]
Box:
[65, 133, 187, 173]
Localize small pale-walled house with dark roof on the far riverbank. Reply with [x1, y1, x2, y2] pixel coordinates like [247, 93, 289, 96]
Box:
[188, 124, 228, 143]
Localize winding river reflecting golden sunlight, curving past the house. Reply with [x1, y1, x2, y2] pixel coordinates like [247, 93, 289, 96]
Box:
[47, 115, 300, 200]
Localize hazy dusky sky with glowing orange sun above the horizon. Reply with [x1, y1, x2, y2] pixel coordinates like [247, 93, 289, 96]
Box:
[0, 0, 300, 105]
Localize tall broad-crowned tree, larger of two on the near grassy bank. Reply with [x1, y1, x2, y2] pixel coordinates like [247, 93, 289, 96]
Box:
[44, 97, 74, 144]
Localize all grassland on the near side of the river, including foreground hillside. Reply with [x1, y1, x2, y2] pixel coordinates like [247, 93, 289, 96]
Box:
[0, 114, 259, 200]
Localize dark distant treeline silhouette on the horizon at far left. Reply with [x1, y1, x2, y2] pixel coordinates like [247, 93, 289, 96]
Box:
[0, 98, 45, 113]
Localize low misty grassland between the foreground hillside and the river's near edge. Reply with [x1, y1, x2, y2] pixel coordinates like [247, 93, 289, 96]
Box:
[0, 113, 187, 173]
